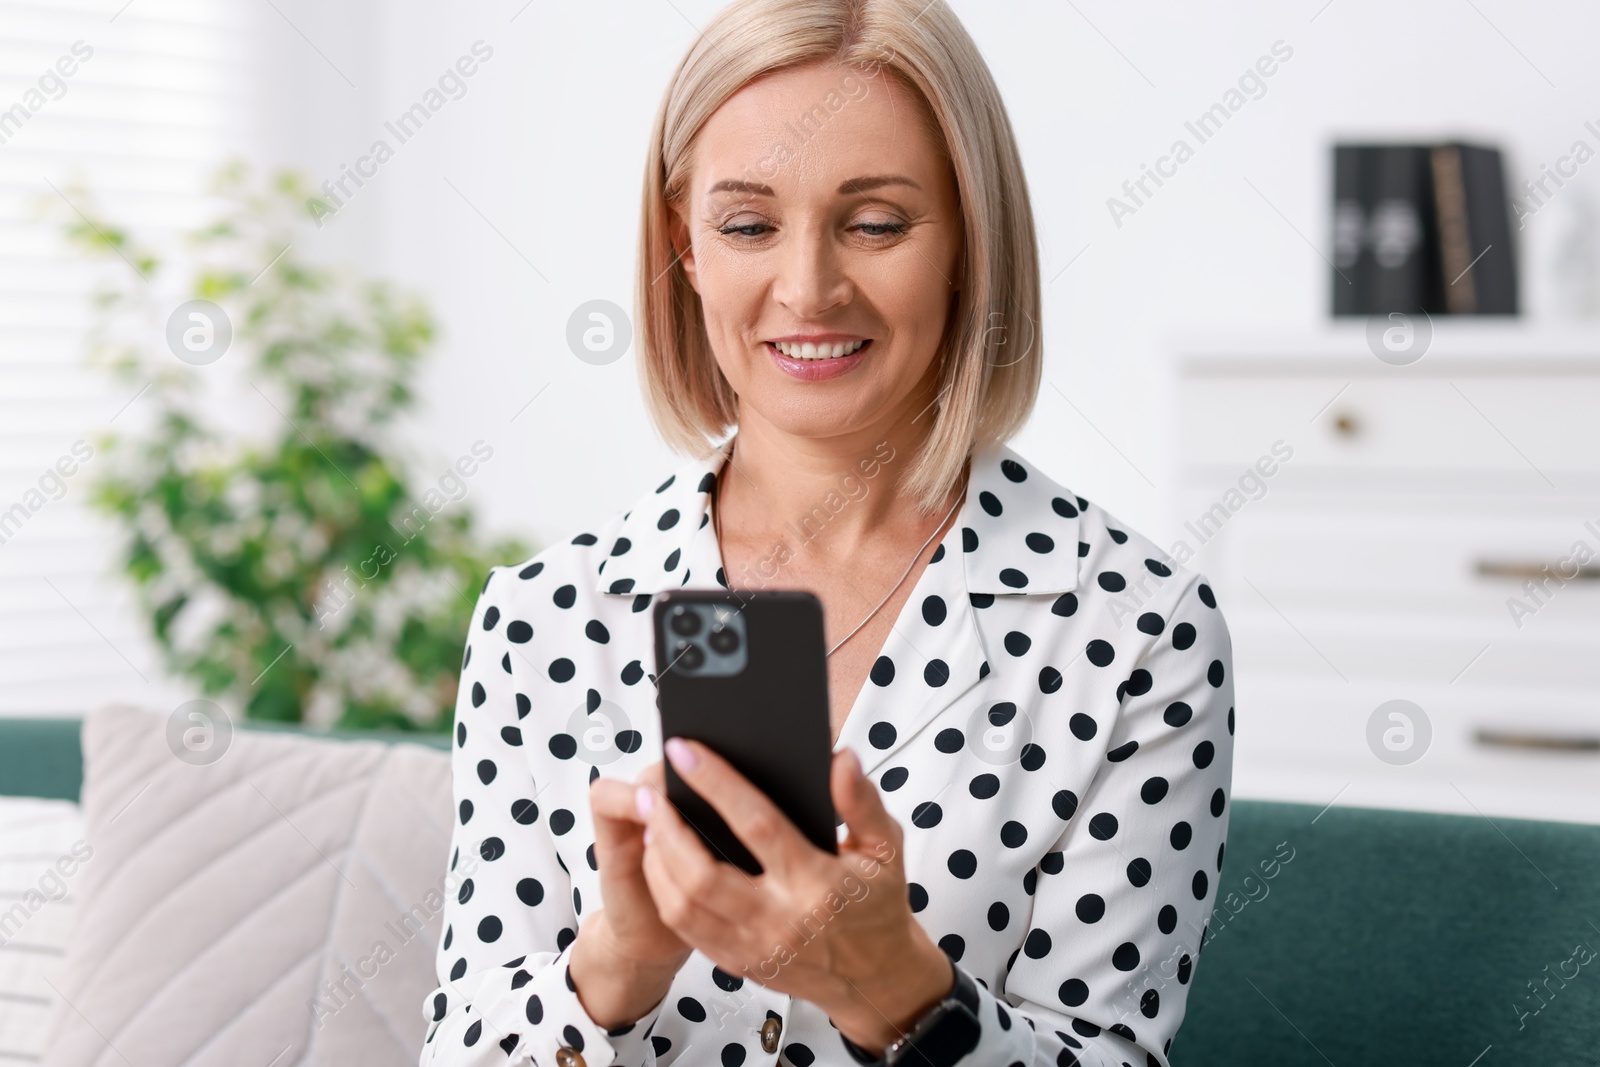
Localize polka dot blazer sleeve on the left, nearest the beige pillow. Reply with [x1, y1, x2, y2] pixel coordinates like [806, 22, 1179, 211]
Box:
[419, 568, 661, 1067]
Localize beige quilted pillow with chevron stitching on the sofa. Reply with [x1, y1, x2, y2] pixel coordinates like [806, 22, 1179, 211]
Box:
[42, 705, 453, 1067]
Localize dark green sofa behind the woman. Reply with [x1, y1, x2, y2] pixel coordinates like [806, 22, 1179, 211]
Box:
[0, 718, 1600, 1067]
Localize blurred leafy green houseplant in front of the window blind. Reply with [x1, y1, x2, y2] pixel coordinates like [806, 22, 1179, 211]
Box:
[54, 162, 531, 731]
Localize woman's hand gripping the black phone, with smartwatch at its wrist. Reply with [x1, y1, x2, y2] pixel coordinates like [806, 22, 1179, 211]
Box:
[640, 737, 955, 1053]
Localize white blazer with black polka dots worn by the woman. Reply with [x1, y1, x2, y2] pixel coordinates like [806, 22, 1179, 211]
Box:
[421, 446, 1234, 1067]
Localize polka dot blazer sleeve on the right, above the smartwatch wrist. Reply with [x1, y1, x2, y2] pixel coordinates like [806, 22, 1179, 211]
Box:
[957, 573, 1234, 1067]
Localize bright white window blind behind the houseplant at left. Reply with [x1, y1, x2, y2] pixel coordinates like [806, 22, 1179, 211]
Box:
[0, 0, 259, 715]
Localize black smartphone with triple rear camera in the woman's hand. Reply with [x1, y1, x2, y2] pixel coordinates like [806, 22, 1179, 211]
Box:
[654, 589, 838, 875]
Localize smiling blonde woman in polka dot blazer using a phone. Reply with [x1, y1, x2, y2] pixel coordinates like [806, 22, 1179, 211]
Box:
[421, 0, 1234, 1067]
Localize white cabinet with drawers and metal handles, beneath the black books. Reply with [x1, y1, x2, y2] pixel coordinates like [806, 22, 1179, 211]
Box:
[1166, 320, 1600, 822]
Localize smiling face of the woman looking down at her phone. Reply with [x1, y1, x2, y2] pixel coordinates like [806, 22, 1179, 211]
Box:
[677, 64, 962, 438]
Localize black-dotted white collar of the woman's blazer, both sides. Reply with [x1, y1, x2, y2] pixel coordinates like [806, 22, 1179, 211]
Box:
[595, 443, 1085, 595]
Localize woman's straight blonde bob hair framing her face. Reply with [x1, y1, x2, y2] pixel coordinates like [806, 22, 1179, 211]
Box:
[634, 0, 1043, 514]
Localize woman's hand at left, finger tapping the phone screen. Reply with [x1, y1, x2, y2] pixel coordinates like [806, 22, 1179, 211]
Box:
[570, 761, 693, 1030]
